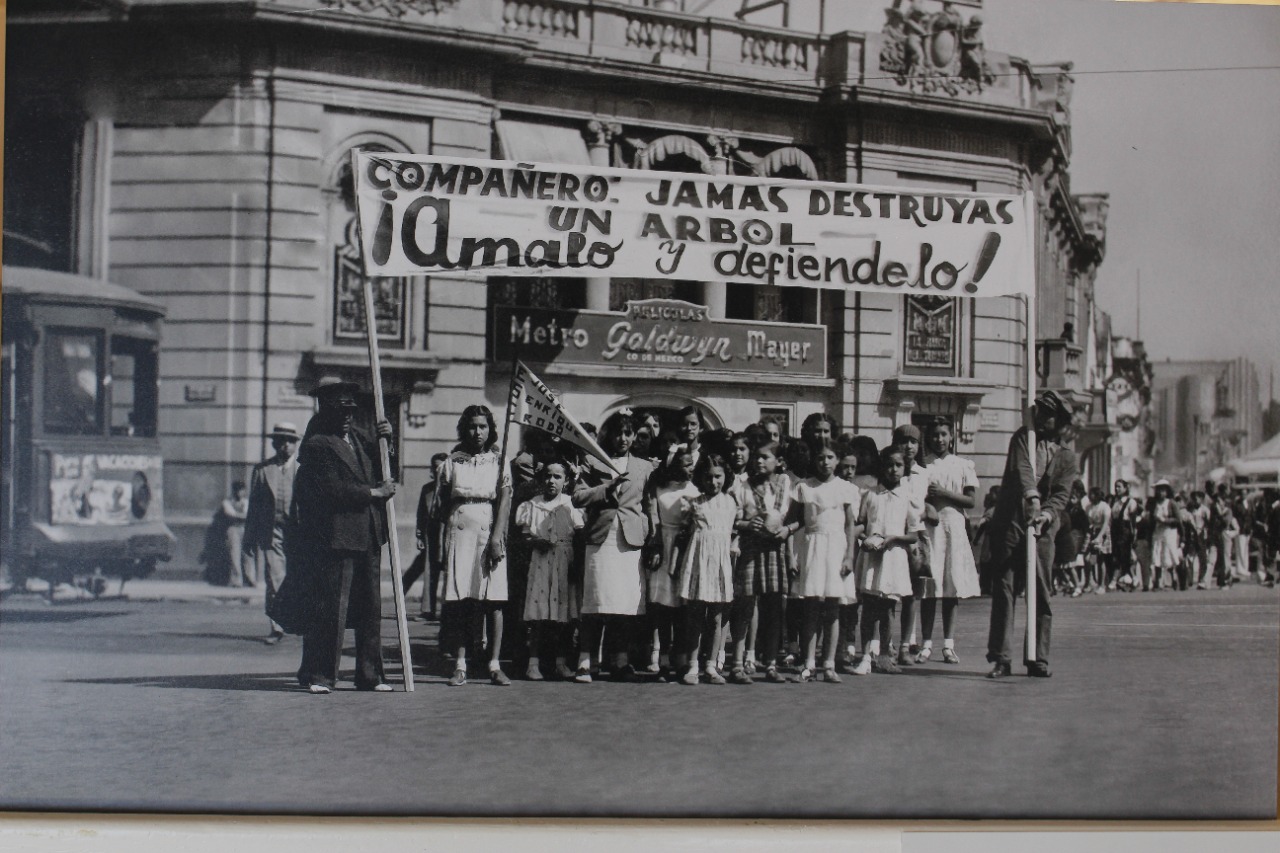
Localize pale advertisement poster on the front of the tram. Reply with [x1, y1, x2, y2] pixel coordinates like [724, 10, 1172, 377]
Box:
[49, 453, 163, 526]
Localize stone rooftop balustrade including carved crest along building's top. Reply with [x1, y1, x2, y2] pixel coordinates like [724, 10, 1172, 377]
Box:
[293, 0, 1044, 103]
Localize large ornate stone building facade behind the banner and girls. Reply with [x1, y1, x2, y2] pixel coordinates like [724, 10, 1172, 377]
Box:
[5, 0, 1110, 564]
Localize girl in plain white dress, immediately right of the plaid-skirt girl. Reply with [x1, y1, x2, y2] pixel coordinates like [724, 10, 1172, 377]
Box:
[788, 438, 861, 683]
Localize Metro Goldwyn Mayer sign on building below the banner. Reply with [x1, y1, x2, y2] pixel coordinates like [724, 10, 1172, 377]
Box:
[492, 300, 827, 378]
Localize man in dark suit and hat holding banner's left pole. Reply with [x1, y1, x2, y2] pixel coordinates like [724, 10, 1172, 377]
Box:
[288, 382, 396, 694]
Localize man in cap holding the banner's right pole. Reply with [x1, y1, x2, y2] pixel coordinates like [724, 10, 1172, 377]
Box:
[987, 391, 1078, 679]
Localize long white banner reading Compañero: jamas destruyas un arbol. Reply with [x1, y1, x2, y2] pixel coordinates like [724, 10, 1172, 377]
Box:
[352, 150, 1034, 296]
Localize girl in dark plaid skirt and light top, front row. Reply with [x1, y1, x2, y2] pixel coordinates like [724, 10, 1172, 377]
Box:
[730, 442, 791, 684]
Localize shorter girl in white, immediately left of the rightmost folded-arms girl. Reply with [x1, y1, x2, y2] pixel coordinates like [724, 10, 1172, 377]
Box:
[854, 444, 922, 675]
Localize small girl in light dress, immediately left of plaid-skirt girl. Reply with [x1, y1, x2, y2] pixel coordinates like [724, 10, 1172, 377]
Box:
[678, 451, 739, 684]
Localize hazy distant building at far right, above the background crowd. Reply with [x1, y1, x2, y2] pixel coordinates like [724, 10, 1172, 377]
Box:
[1152, 357, 1263, 485]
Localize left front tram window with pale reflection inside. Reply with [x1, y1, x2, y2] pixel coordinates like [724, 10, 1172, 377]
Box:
[44, 329, 102, 435]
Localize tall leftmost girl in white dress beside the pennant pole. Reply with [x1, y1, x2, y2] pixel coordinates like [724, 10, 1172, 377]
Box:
[435, 406, 511, 686]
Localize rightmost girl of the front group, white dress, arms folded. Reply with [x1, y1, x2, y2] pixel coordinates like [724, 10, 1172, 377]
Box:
[915, 420, 980, 663]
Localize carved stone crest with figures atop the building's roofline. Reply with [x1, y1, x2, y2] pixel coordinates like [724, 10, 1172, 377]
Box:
[881, 0, 996, 95]
